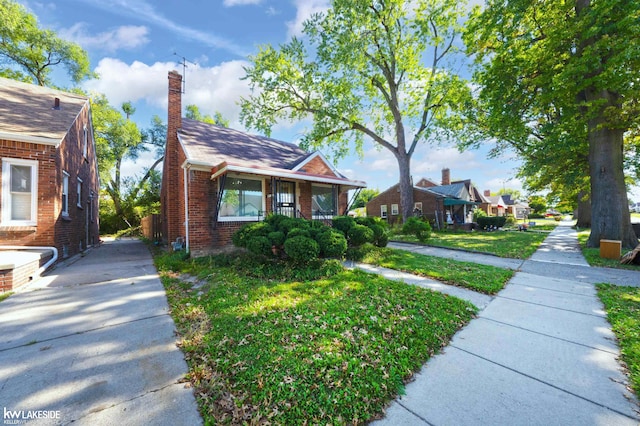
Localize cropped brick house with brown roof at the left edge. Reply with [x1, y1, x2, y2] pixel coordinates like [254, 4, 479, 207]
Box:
[0, 78, 99, 292]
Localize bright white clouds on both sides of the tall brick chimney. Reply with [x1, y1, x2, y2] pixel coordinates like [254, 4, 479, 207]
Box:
[83, 58, 249, 128]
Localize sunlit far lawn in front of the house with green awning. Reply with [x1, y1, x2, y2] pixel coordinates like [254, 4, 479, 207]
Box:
[392, 231, 547, 259]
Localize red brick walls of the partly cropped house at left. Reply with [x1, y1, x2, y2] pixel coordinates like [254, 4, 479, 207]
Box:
[0, 103, 99, 257]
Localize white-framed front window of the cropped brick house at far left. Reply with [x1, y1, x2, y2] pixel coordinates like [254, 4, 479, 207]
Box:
[2, 158, 38, 226]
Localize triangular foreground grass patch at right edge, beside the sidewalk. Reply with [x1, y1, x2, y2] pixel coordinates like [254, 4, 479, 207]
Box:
[597, 284, 640, 395]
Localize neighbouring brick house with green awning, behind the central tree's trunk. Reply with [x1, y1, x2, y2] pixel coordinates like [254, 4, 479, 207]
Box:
[366, 169, 486, 229]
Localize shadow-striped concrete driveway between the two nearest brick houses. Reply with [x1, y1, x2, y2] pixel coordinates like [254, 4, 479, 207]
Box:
[0, 239, 202, 425]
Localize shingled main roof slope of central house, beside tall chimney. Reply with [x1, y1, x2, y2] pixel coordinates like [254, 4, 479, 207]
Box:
[178, 118, 311, 170]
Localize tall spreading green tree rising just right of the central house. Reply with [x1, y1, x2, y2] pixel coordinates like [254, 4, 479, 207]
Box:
[241, 0, 468, 218]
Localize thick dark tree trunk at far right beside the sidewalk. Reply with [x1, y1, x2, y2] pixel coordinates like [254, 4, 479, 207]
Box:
[587, 90, 638, 249]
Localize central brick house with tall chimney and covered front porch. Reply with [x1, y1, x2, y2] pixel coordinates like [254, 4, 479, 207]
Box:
[160, 71, 366, 253]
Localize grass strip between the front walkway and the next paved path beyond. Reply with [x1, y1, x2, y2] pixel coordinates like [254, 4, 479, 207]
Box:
[361, 247, 514, 294]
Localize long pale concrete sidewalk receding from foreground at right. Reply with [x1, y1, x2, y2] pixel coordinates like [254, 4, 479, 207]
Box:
[374, 224, 640, 425]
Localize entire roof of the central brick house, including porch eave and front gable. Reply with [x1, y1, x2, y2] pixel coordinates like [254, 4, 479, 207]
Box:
[178, 118, 366, 187]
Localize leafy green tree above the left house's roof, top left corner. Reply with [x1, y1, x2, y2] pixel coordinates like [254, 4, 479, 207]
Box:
[0, 0, 91, 86]
